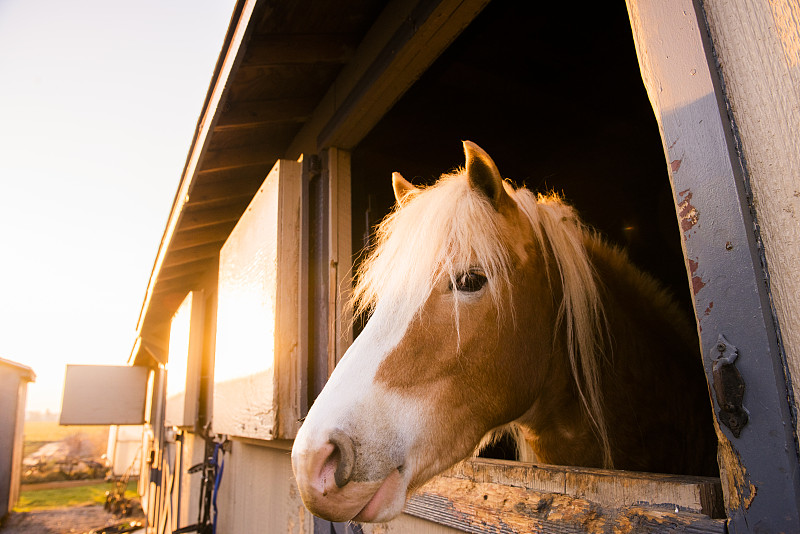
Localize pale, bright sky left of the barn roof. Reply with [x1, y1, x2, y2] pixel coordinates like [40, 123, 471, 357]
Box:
[0, 0, 234, 412]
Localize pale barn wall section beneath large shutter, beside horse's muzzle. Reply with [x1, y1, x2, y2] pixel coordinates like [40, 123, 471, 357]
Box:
[217, 439, 313, 534]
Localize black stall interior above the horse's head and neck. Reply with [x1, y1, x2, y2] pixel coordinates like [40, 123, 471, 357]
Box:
[352, 0, 692, 313]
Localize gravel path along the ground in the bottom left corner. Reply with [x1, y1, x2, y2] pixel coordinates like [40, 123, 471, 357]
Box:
[0, 505, 144, 534]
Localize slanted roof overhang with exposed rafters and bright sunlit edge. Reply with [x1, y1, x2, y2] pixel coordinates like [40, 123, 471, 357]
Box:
[132, 0, 382, 360]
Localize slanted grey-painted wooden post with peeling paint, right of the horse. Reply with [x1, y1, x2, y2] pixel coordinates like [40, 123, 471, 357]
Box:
[628, 0, 800, 532]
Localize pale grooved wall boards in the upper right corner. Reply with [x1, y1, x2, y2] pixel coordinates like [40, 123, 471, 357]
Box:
[703, 0, 800, 442]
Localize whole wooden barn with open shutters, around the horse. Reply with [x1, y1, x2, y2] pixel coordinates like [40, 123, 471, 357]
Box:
[79, 0, 800, 534]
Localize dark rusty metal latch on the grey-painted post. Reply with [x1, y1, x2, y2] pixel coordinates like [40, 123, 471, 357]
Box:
[712, 334, 750, 438]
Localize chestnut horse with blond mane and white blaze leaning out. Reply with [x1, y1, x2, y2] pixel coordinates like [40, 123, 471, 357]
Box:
[292, 141, 717, 522]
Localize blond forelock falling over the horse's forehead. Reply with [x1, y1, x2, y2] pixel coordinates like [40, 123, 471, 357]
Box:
[353, 171, 511, 326]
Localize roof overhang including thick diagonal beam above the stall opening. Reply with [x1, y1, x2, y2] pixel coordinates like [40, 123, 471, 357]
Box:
[131, 0, 488, 363]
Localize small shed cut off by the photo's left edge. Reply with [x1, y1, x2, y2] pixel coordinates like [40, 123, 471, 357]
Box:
[0, 358, 36, 517]
